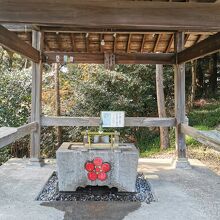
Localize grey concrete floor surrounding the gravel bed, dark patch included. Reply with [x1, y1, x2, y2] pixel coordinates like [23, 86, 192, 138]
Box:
[0, 159, 220, 220]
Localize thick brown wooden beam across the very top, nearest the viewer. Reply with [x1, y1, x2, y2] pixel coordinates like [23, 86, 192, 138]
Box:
[0, 0, 220, 31]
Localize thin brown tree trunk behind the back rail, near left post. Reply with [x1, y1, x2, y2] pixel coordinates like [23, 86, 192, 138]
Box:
[54, 63, 62, 148]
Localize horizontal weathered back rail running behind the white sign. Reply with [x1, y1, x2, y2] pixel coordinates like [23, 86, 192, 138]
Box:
[41, 116, 176, 127]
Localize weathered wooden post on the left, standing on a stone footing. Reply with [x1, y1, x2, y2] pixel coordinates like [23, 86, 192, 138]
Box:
[30, 31, 43, 162]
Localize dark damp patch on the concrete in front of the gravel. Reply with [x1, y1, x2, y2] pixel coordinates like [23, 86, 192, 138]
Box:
[41, 201, 141, 220]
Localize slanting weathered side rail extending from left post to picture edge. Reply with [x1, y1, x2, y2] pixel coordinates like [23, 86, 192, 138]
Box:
[0, 122, 38, 148]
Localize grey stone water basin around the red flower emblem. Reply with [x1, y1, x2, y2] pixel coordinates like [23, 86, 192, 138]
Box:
[56, 143, 139, 192]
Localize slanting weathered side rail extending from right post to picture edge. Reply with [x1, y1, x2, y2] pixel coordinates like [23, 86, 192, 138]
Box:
[181, 124, 220, 151]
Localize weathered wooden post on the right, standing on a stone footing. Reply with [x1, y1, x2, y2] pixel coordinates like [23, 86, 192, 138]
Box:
[174, 32, 186, 158]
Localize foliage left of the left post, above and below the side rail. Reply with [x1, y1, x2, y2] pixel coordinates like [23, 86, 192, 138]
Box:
[0, 49, 31, 164]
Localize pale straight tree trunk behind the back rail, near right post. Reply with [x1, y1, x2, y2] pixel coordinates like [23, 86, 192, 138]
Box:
[156, 64, 169, 150]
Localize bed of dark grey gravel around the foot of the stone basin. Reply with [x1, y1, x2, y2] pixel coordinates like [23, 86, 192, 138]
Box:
[37, 172, 155, 204]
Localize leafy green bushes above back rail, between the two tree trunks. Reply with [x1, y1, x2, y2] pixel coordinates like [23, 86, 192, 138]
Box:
[66, 65, 156, 116]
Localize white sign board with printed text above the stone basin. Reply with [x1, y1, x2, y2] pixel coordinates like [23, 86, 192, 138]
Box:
[101, 111, 125, 128]
